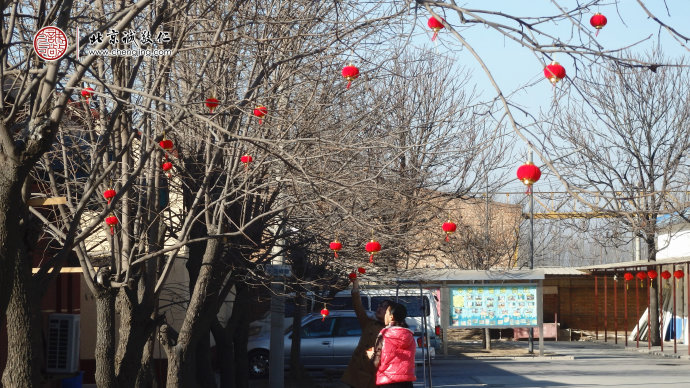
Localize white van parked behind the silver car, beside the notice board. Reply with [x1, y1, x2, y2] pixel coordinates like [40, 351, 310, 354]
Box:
[328, 288, 441, 353]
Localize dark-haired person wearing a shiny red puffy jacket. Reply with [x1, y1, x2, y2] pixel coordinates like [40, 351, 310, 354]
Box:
[367, 303, 417, 388]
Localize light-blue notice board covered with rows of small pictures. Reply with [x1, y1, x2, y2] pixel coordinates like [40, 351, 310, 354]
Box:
[450, 284, 541, 328]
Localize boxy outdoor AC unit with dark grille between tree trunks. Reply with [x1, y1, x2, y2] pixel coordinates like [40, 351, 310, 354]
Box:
[46, 314, 79, 373]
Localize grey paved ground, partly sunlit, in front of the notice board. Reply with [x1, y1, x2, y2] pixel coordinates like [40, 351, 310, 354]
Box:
[250, 342, 690, 388]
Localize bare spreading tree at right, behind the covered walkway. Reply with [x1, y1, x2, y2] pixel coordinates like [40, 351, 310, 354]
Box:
[543, 54, 690, 344]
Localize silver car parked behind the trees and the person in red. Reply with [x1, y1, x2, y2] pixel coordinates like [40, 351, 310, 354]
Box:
[247, 310, 436, 377]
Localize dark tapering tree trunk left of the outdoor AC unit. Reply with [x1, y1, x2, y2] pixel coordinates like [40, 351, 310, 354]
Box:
[2, 249, 42, 388]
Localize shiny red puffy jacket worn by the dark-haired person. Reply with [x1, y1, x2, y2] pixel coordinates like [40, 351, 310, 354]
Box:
[376, 326, 417, 385]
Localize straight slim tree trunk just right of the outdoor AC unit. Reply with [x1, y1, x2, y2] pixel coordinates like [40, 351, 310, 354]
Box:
[95, 289, 118, 388]
